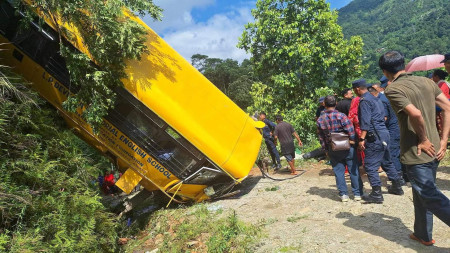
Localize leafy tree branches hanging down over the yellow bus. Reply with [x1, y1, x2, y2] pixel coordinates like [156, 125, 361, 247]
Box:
[20, 0, 161, 128]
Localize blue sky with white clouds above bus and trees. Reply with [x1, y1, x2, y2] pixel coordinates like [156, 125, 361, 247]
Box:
[143, 0, 351, 62]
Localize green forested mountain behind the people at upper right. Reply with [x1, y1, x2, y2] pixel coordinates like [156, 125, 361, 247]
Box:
[338, 0, 450, 81]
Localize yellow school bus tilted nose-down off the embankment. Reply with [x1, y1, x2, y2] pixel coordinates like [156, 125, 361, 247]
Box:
[0, 0, 262, 202]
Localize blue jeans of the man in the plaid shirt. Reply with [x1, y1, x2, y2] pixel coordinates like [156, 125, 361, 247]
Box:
[328, 146, 363, 196]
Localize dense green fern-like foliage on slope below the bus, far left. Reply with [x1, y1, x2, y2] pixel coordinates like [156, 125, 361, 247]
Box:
[0, 67, 117, 252]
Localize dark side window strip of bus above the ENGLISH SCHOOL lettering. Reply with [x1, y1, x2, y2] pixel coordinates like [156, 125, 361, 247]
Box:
[106, 89, 203, 178]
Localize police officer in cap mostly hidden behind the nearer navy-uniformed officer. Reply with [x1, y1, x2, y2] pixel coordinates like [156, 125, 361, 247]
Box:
[371, 79, 405, 185]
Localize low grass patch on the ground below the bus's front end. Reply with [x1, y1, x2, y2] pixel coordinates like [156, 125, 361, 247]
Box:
[123, 204, 263, 252]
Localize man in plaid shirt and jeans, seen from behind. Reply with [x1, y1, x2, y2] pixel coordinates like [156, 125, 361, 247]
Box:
[317, 96, 363, 202]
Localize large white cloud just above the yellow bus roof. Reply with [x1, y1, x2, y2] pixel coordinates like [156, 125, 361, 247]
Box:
[144, 0, 253, 61]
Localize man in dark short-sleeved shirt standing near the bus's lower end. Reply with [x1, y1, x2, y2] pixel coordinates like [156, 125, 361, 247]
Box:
[273, 115, 303, 175]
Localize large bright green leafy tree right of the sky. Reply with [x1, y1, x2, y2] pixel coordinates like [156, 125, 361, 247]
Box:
[238, 0, 364, 110]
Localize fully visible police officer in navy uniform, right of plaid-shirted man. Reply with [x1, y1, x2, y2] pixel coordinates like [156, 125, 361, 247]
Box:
[352, 79, 403, 203]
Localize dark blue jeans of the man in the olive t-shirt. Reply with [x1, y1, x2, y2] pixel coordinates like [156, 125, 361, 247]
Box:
[405, 160, 450, 242]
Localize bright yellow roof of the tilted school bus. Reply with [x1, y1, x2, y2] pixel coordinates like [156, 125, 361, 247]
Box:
[122, 20, 262, 178]
